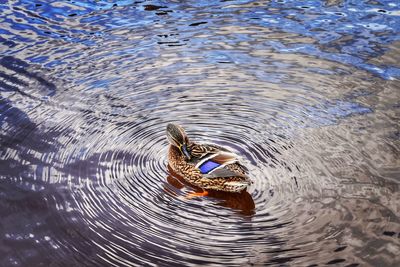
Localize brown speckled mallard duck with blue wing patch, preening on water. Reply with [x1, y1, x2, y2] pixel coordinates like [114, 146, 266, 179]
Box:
[167, 123, 251, 196]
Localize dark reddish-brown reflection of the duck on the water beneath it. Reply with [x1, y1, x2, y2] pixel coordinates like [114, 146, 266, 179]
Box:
[164, 168, 255, 216]
